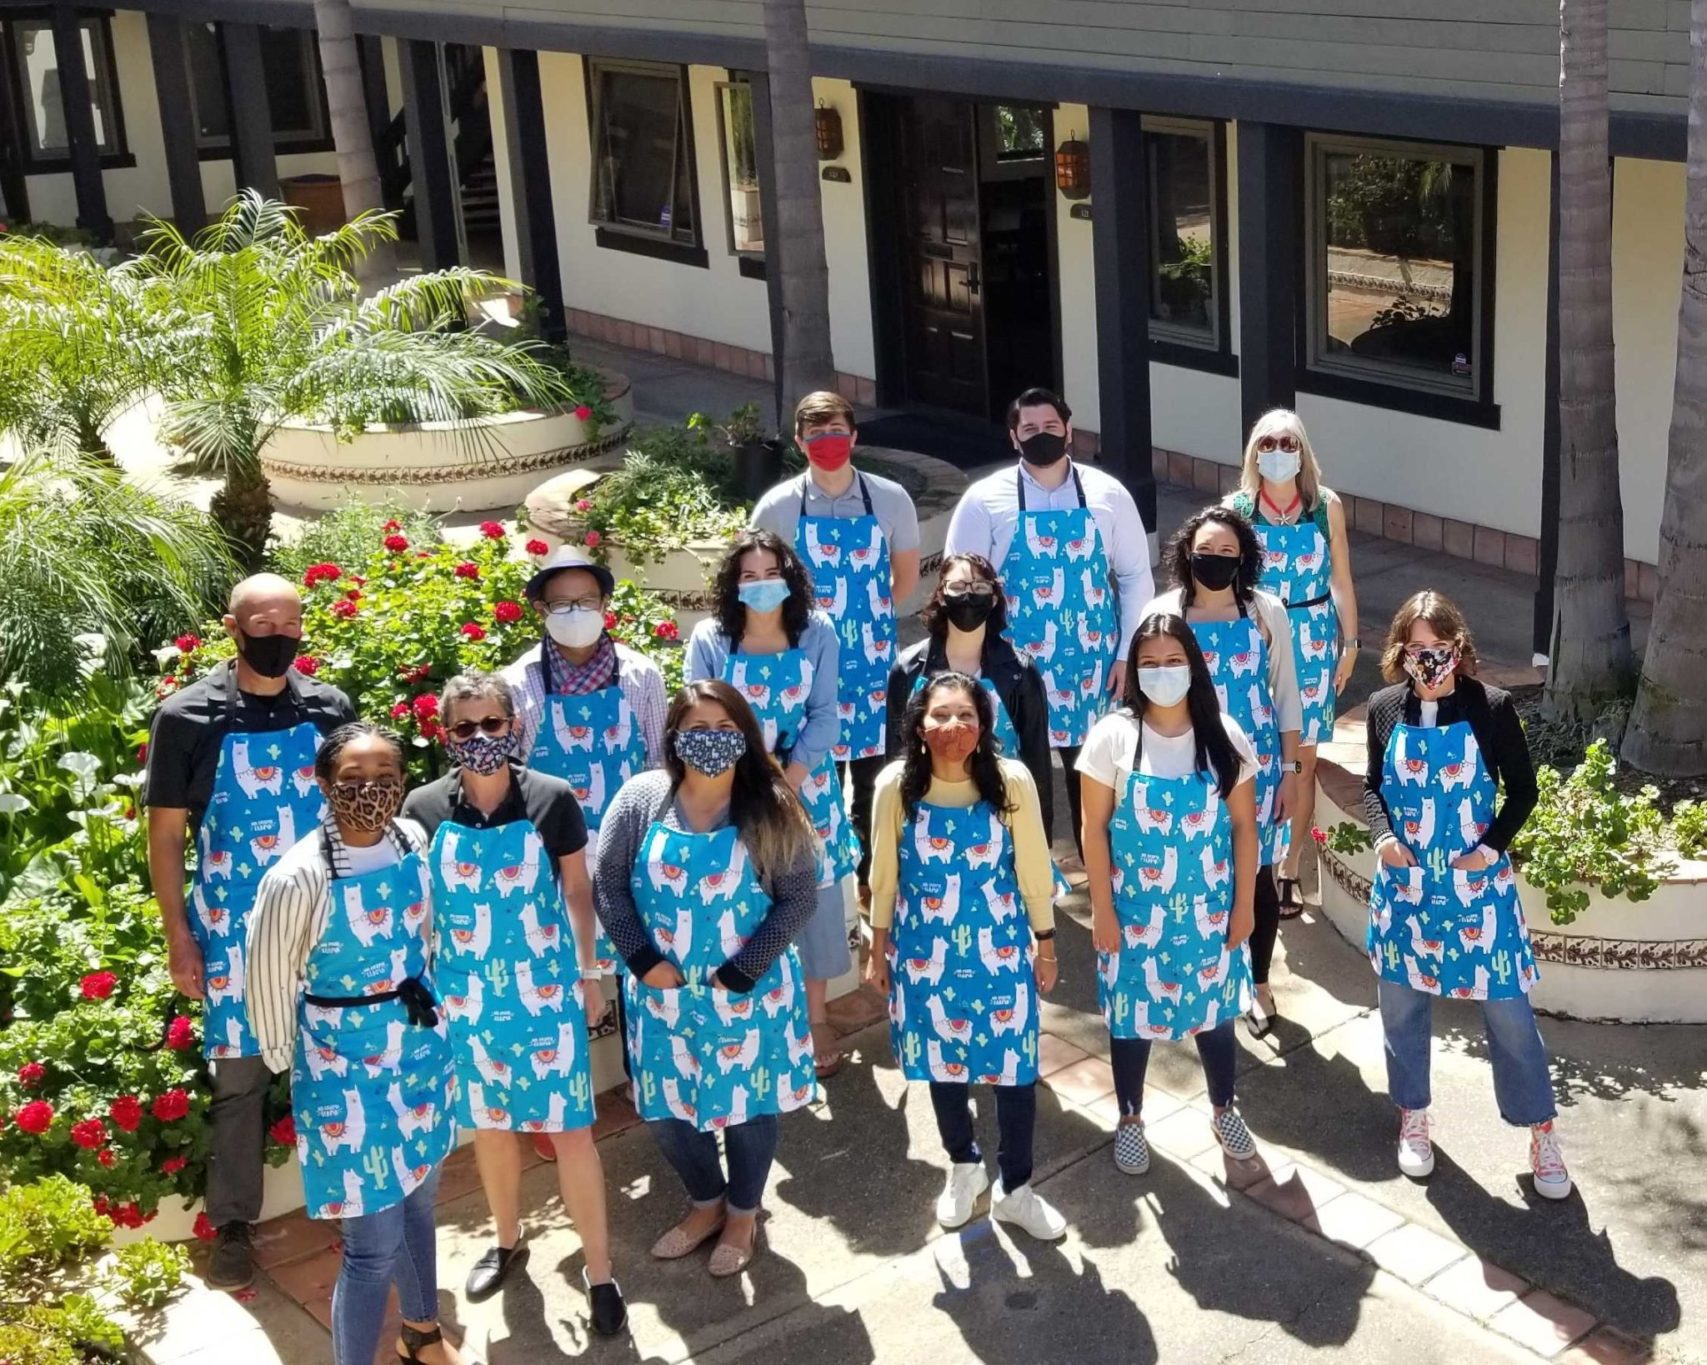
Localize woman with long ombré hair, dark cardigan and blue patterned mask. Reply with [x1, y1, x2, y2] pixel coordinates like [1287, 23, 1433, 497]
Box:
[592, 679, 823, 1278]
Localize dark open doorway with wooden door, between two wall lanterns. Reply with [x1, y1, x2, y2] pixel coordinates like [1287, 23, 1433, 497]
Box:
[862, 92, 1060, 427]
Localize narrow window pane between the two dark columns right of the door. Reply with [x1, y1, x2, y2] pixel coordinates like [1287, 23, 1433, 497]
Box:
[1144, 133, 1215, 338]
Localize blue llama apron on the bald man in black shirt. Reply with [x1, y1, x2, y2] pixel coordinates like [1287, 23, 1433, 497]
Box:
[189, 709, 326, 1061]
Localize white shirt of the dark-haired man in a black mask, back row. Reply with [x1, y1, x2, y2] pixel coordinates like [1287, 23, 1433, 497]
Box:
[942, 461, 1156, 660]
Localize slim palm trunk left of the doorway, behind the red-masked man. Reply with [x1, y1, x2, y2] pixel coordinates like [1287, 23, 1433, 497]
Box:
[765, 0, 836, 403]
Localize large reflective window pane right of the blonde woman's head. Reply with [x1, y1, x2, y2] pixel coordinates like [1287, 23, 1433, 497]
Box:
[1318, 152, 1477, 387]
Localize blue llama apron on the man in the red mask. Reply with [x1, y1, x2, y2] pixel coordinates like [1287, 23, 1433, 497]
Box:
[794, 474, 898, 763]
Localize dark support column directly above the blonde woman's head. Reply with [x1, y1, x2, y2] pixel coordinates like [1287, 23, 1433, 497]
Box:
[1238, 121, 1304, 440]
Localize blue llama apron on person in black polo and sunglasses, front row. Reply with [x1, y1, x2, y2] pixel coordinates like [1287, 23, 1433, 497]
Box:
[427, 819, 592, 1133]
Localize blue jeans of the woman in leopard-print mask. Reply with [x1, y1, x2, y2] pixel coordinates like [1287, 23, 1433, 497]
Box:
[331, 1169, 439, 1365]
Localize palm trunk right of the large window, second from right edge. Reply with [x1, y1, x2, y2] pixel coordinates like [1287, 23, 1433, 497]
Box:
[1547, 0, 1632, 720]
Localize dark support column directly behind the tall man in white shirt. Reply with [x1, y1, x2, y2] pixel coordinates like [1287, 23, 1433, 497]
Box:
[1091, 107, 1156, 539]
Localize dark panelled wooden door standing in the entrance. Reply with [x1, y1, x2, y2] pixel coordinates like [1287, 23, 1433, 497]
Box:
[898, 96, 990, 418]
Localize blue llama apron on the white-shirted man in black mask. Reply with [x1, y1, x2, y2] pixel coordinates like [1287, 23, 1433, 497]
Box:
[1000, 469, 1120, 749]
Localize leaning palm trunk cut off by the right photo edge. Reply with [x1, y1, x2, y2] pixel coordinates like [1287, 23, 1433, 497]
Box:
[1623, 0, 1707, 775]
